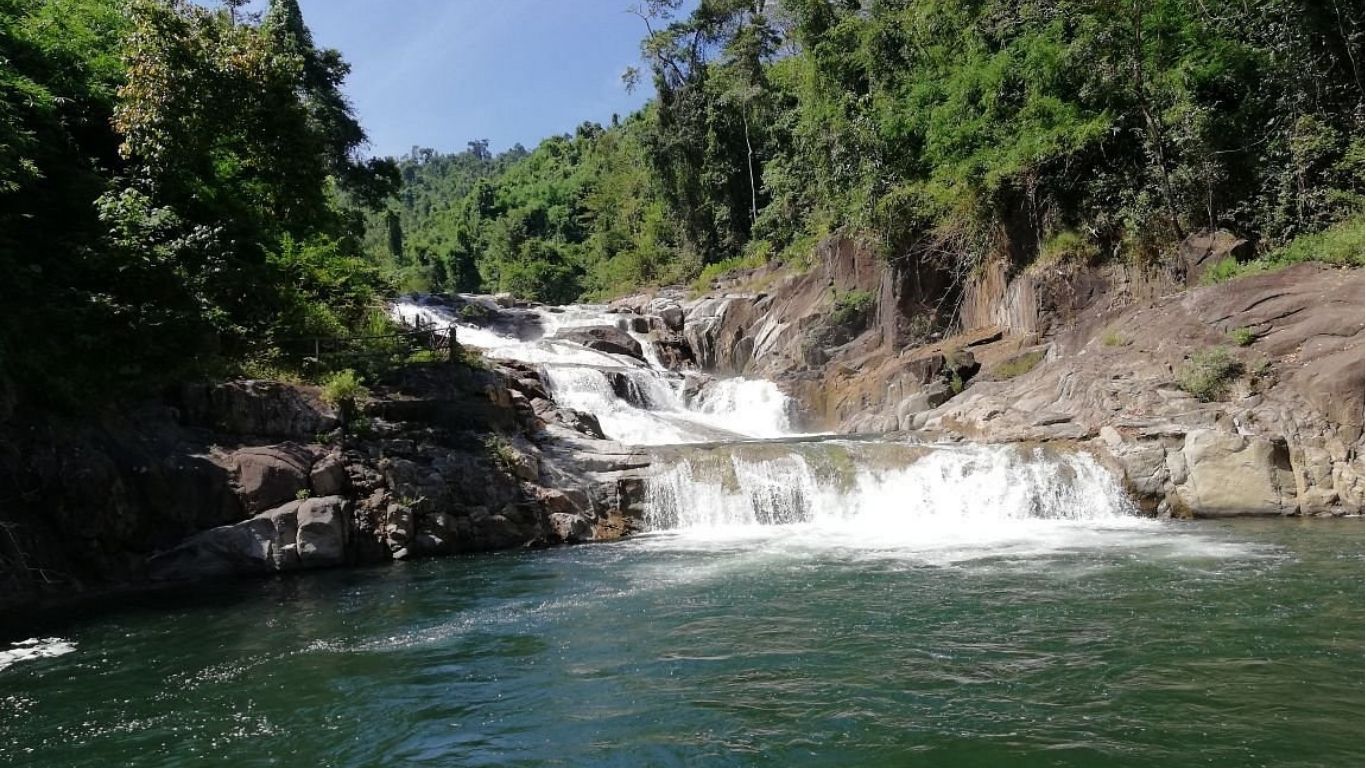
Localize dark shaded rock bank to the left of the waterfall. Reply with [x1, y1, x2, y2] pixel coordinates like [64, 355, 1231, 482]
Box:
[0, 365, 643, 604]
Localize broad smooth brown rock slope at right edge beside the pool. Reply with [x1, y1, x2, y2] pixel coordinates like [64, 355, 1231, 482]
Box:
[923, 265, 1363, 517]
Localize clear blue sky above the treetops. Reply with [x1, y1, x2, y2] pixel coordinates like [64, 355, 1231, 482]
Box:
[277, 0, 666, 154]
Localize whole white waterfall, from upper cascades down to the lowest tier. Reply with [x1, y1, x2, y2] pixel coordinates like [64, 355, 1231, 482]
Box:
[392, 297, 1135, 532]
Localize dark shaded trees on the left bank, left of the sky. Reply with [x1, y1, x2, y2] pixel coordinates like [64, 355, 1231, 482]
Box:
[0, 0, 398, 414]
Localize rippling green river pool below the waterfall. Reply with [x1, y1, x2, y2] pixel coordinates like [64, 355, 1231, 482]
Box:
[0, 521, 1363, 768]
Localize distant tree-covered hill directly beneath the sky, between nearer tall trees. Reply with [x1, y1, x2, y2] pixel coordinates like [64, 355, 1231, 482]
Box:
[367, 112, 691, 301]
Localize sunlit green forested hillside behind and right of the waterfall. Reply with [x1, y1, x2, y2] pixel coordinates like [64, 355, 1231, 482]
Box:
[369, 0, 1363, 301]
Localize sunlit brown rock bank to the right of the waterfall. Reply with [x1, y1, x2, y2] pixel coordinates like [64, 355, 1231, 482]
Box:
[617, 235, 1363, 517]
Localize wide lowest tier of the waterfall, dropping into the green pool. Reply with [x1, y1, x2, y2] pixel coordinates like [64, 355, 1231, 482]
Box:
[645, 440, 1134, 533]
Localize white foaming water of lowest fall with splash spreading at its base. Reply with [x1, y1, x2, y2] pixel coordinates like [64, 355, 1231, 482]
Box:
[634, 443, 1279, 570]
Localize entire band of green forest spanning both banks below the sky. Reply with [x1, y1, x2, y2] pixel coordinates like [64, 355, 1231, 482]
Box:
[0, 0, 1363, 413]
